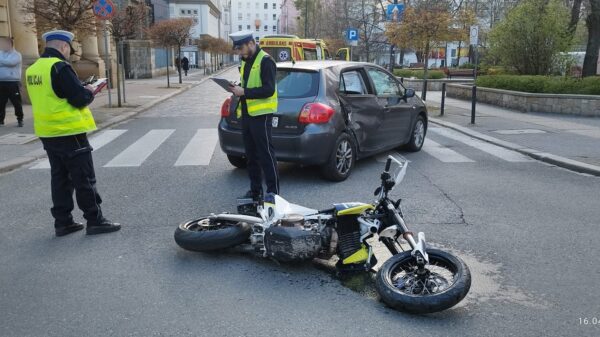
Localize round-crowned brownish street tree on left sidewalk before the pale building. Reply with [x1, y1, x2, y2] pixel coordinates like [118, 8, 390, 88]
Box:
[148, 18, 194, 87]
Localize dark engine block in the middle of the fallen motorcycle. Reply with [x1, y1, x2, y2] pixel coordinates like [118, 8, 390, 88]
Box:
[264, 215, 324, 262]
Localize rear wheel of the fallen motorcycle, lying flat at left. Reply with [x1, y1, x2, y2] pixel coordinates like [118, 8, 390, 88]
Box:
[174, 218, 251, 252]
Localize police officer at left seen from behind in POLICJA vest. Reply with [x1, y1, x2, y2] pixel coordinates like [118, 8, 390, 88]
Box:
[26, 30, 121, 236]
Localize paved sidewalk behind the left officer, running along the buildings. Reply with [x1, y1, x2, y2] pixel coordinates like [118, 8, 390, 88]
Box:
[0, 67, 230, 173]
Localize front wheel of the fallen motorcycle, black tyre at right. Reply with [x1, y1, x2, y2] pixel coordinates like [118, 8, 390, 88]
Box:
[375, 249, 471, 314]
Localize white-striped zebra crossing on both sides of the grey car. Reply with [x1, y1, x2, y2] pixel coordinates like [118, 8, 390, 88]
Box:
[30, 127, 531, 170]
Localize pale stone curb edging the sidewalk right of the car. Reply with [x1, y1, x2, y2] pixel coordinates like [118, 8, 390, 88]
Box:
[429, 117, 600, 177]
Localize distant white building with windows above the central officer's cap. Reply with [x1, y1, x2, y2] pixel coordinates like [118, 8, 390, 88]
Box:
[231, 0, 284, 40]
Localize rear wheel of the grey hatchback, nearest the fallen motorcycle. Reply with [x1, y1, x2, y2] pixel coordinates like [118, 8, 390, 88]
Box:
[321, 133, 356, 181]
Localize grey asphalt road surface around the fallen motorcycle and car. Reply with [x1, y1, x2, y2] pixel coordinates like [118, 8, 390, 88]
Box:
[0, 72, 600, 336]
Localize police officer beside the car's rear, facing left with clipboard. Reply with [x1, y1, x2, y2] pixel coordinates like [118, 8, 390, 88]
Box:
[229, 31, 279, 199]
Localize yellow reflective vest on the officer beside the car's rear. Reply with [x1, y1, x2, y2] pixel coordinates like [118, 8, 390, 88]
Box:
[236, 49, 277, 118]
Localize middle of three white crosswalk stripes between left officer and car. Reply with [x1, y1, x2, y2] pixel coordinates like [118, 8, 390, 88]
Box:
[104, 129, 175, 167]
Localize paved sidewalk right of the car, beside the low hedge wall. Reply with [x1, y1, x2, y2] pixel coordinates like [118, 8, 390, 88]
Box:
[427, 91, 600, 176]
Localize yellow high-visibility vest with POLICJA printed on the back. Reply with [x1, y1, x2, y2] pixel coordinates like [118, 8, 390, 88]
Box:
[25, 57, 96, 138]
